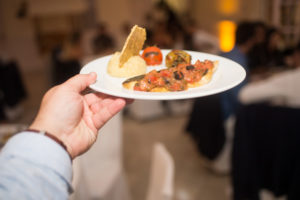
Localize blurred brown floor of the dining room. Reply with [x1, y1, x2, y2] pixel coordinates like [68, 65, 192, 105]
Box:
[8, 71, 230, 200]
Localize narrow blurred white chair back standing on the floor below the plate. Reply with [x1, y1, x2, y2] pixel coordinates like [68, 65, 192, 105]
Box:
[146, 143, 175, 200]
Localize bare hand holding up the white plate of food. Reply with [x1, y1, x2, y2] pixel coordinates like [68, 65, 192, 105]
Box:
[29, 73, 131, 158]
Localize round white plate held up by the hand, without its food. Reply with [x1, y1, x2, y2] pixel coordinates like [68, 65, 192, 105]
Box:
[80, 50, 246, 100]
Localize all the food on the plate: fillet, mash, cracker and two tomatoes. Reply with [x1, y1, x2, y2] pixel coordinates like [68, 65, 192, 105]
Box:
[107, 25, 217, 92]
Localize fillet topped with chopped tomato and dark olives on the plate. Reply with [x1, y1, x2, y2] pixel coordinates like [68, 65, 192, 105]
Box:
[123, 60, 217, 92]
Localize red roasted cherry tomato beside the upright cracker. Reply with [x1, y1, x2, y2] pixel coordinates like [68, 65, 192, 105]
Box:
[142, 46, 163, 65]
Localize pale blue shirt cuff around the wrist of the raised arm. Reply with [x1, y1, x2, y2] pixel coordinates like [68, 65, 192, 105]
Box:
[1, 131, 72, 185]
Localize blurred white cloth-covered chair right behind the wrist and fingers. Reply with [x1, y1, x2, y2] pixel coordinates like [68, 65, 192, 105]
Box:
[71, 113, 130, 200]
